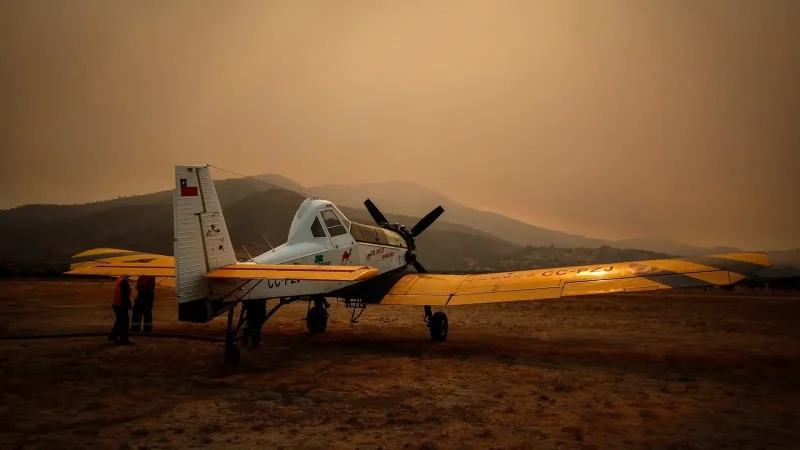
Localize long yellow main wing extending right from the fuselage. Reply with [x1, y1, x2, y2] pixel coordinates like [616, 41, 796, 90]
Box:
[380, 253, 770, 306]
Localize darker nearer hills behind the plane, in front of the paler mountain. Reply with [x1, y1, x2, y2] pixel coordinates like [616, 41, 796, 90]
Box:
[0, 180, 518, 270]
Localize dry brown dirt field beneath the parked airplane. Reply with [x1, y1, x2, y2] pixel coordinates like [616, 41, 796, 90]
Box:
[0, 281, 800, 449]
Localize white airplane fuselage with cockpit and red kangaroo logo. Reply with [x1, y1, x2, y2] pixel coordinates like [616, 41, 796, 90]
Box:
[212, 199, 407, 301]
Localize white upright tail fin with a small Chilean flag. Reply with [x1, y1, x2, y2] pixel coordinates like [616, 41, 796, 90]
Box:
[173, 166, 237, 322]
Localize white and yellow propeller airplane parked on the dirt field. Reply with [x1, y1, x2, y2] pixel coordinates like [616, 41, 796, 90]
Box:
[65, 165, 770, 365]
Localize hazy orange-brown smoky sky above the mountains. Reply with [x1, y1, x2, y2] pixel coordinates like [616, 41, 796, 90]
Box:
[0, 0, 800, 249]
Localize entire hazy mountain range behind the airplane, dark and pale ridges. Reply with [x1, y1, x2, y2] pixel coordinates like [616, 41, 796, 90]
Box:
[0, 174, 800, 270]
